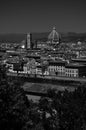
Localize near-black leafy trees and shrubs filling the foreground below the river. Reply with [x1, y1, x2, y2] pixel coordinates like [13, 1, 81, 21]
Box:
[0, 66, 86, 130]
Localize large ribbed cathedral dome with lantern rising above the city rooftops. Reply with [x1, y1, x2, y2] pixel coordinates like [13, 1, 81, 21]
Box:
[48, 27, 59, 42]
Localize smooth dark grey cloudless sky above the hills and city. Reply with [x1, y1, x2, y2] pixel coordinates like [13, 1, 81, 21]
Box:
[0, 0, 86, 33]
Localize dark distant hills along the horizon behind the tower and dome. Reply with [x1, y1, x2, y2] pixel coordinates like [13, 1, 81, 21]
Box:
[0, 32, 86, 43]
